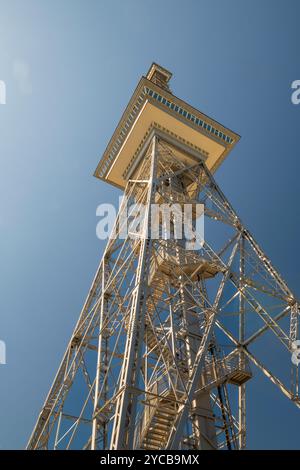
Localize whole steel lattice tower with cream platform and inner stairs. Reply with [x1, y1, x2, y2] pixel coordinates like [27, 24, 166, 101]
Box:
[28, 64, 300, 450]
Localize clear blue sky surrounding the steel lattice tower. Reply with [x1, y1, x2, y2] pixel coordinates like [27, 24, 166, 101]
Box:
[0, 0, 300, 449]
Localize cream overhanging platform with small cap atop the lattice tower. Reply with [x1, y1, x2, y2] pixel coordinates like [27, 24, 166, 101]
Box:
[94, 63, 240, 189]
